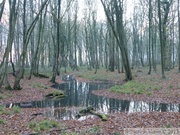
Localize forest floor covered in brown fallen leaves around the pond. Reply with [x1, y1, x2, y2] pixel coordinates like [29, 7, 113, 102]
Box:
[0, 68, 180, 135]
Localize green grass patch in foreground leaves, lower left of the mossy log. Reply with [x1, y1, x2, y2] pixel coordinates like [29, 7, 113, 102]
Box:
[29, 120, 60, 131]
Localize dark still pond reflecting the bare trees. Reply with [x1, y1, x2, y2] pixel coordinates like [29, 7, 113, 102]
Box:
[6, 77, 180, 120]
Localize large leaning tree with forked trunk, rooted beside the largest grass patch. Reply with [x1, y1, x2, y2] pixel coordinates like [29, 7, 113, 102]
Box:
[101, 0, 133, 81]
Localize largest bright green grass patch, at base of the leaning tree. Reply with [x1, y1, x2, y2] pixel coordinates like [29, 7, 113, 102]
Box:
[110, 81, 152, 95]
